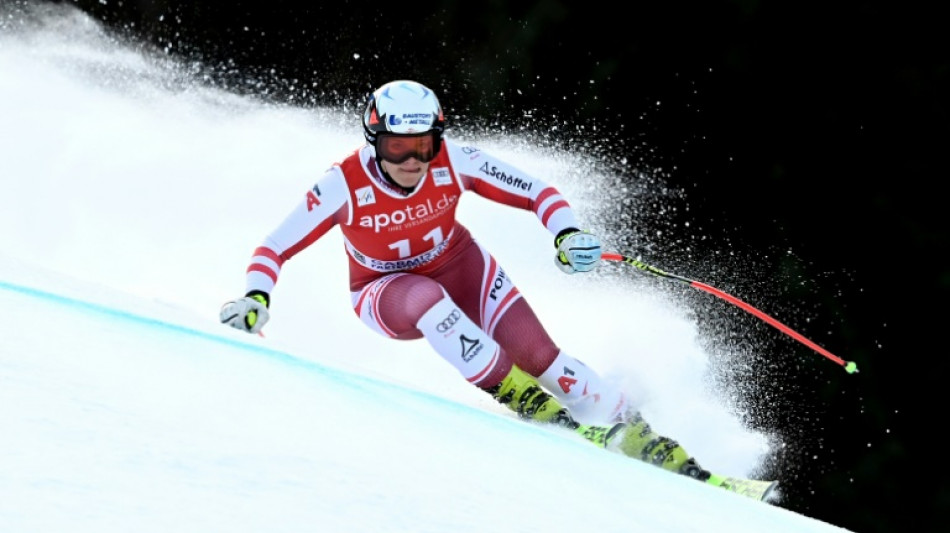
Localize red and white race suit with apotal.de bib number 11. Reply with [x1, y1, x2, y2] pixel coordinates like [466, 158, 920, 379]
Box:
[240, 140, 624, 424]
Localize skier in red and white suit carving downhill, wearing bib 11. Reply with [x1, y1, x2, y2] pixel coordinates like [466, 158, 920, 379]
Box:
[220, 80, 776, 498]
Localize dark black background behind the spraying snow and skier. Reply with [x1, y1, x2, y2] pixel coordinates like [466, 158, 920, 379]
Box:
[54, 0, 950, 533]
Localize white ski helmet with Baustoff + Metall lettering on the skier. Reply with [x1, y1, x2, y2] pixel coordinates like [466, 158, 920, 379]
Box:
[363, 80, 445, 143]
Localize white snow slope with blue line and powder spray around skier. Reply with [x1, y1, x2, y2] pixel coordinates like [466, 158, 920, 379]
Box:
[0, 6, 856, 533]
